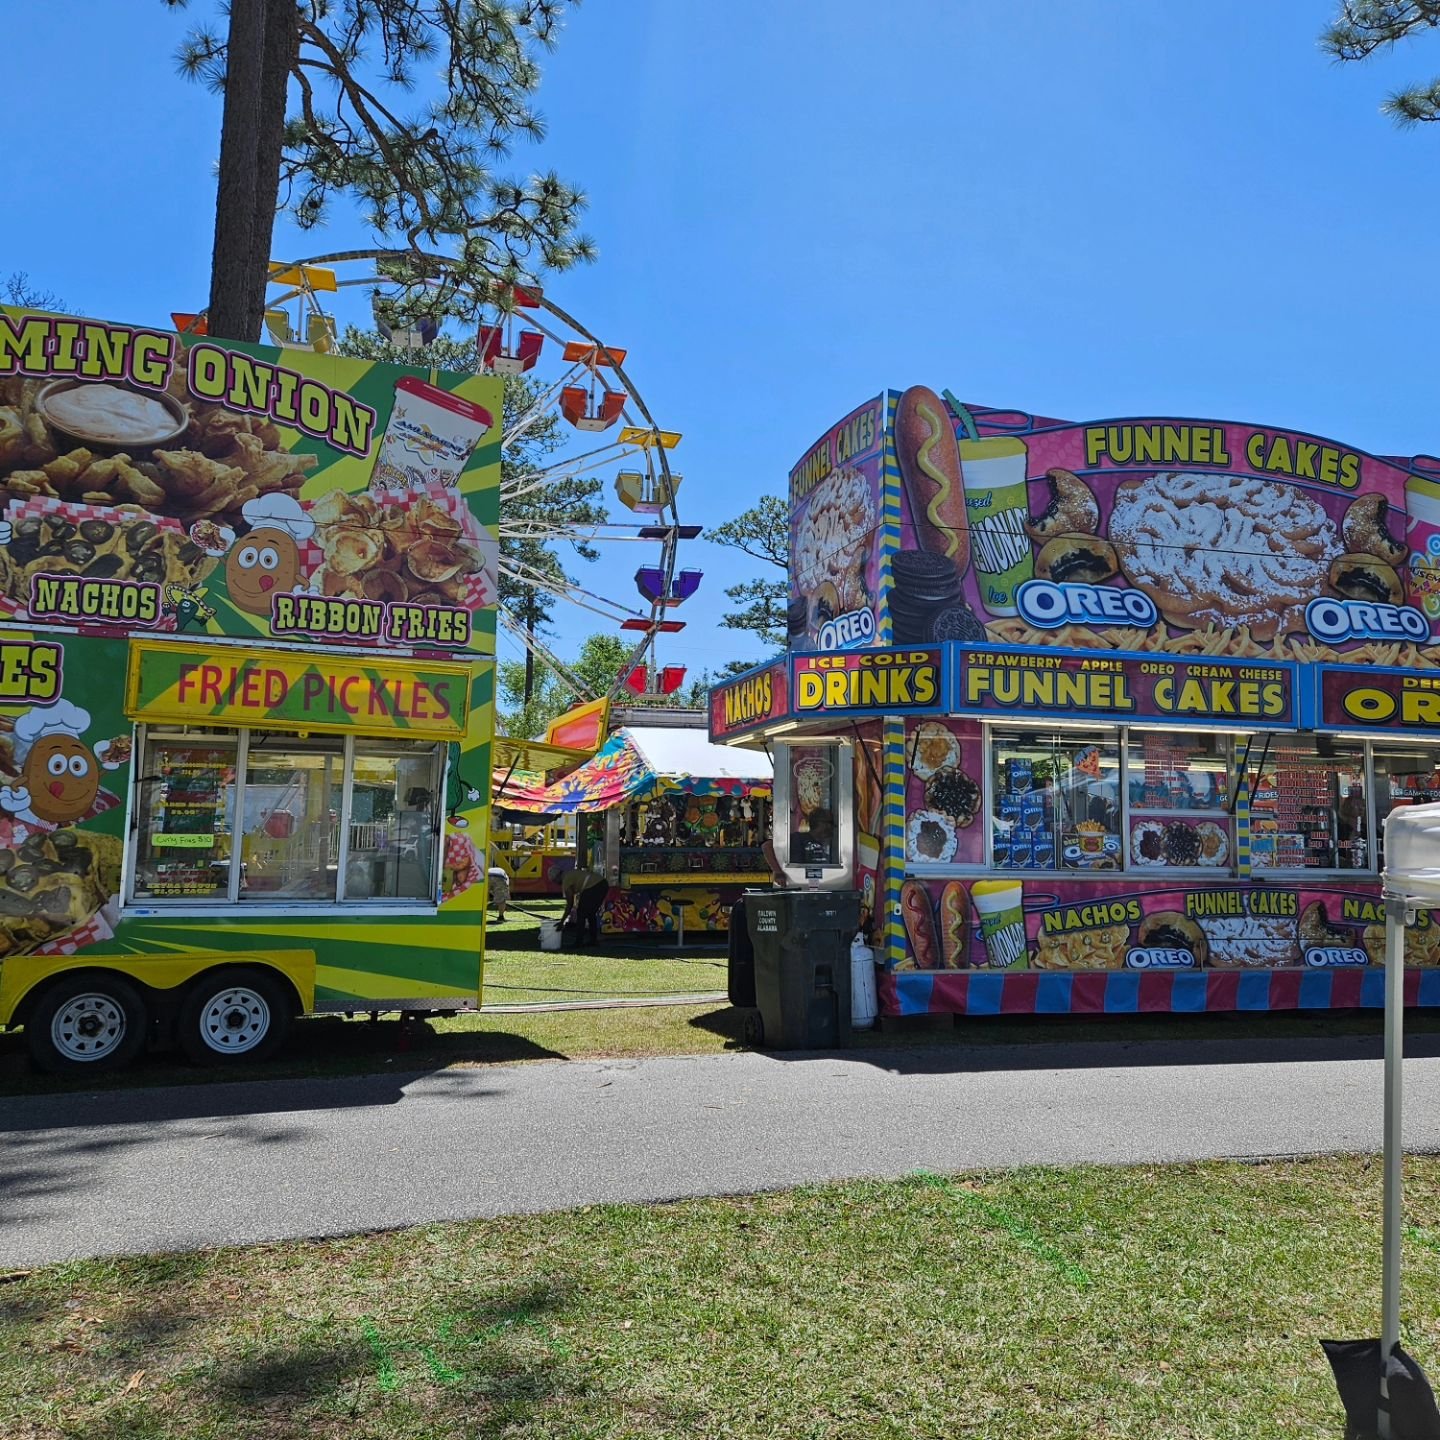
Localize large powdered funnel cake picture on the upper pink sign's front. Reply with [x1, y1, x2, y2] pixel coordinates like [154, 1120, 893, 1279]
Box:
[1110, 472, 1344, 641]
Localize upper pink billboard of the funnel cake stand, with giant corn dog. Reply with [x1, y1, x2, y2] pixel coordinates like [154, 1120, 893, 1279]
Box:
[792, 386, 1440, 670]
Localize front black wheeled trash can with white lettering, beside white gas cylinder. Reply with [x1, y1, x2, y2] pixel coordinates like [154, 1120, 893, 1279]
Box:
[744, 890, 860, 1050]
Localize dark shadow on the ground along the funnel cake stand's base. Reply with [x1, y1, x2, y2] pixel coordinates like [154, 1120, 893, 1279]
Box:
[690, 1007, 1440, 1074]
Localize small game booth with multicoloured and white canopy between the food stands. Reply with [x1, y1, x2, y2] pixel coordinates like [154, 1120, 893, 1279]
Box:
[495, 713, 772, 942]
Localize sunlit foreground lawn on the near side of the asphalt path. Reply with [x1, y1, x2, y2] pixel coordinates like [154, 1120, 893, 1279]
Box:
[0, 1158, 1440, 1440]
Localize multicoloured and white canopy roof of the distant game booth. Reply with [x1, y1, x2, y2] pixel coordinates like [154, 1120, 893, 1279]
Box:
[492, 726, 772, 815]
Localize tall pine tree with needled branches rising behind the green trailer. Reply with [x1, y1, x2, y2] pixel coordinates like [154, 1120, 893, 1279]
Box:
[163, 0, 593, 340]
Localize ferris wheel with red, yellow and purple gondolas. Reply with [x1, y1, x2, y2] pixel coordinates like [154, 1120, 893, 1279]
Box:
[171, 249, 703, 714]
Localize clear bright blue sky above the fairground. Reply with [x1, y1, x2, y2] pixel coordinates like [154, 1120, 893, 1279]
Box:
[14, 0, 1440, 685]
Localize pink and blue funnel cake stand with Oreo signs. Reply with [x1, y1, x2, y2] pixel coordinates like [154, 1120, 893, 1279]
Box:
[711, 387, 1440, 1014]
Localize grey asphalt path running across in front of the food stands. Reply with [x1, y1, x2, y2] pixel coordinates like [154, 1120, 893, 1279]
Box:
[0, 1035, 1440, 1270]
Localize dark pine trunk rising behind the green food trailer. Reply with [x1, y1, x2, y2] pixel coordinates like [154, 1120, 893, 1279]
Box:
[209, 0, 268, 340]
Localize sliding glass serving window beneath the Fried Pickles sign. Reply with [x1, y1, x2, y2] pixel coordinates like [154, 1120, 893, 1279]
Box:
[130, 730, 445, 904]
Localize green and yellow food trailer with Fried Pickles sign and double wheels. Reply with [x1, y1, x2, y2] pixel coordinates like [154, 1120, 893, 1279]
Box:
[0, 303, 501, 1071]
